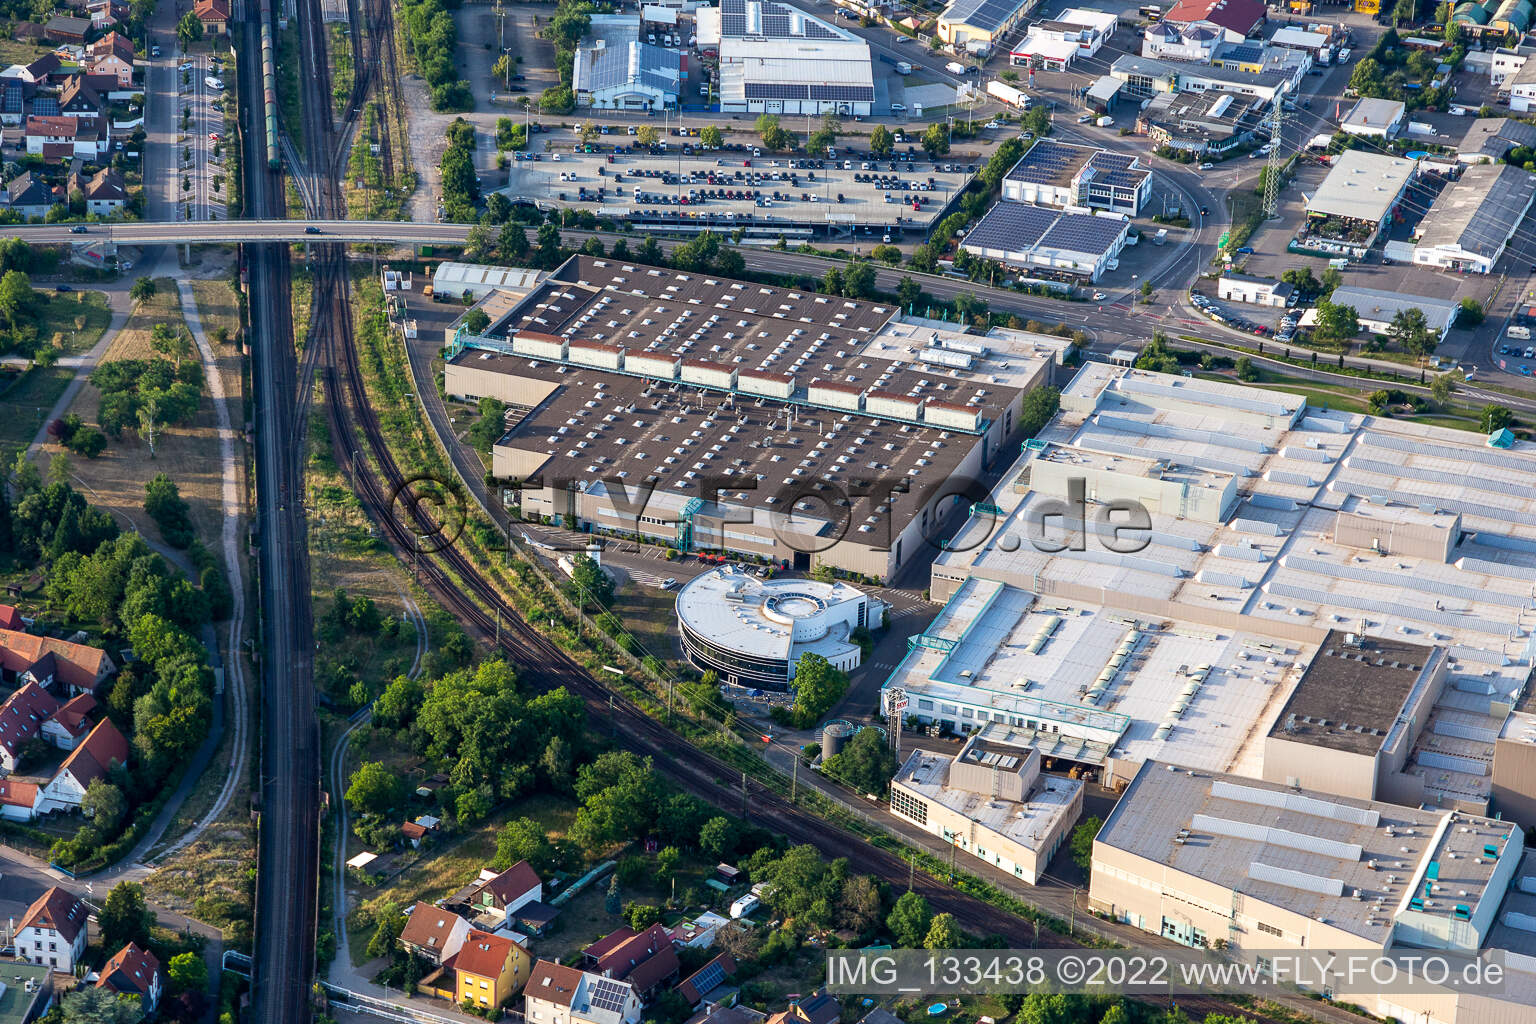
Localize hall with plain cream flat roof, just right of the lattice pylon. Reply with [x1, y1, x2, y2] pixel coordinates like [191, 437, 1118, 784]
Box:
[1306, 149, 1416, 255]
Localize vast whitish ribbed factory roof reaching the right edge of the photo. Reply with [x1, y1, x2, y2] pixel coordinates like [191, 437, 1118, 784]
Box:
[934, 362, 1536, 801]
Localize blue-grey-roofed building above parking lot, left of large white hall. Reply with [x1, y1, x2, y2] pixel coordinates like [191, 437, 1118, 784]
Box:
[571, 14, 684, 111]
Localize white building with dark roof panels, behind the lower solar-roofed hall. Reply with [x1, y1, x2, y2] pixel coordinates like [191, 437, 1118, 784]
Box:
[1003, 138, 1152, 216]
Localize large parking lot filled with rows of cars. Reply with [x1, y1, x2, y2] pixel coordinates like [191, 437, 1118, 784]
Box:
[505, 127, 977, 235]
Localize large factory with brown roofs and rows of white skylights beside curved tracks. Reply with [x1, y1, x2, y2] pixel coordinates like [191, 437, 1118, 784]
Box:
[444, 256, 1057, 579]
